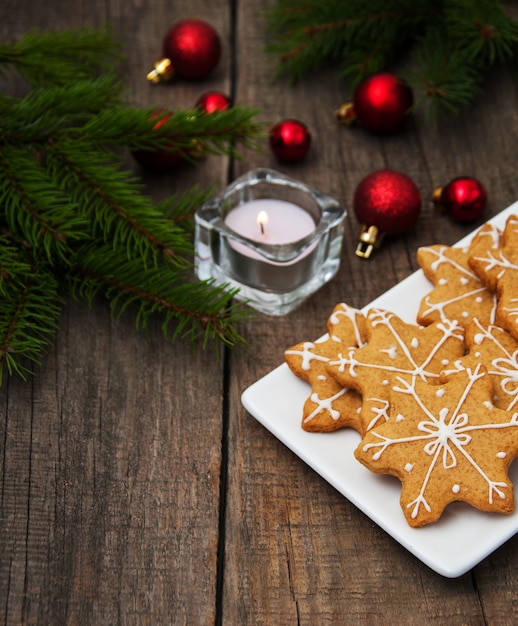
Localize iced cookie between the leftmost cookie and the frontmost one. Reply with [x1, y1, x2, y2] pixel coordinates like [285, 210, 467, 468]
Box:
[327, 309, 465, 432]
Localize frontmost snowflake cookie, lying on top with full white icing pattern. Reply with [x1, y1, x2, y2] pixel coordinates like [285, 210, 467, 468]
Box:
[355, 363, 518, 527]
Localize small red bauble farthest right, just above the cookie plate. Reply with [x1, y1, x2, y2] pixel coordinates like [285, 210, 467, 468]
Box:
[433, 176, 487, 222]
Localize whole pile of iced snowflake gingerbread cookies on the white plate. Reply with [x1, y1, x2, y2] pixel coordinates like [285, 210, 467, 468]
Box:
[285, 216, 518, 527]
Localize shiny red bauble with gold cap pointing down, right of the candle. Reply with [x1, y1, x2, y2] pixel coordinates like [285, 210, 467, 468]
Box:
[353, 169, 421, 258]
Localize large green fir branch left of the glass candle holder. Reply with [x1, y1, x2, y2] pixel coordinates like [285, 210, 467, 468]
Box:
[0, 28, 264, 384]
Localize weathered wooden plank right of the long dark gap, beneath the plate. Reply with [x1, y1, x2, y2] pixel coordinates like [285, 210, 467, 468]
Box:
[223, 2, 518, 624]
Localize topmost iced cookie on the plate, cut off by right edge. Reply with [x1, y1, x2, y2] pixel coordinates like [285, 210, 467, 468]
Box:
[469, 215, 518, 339]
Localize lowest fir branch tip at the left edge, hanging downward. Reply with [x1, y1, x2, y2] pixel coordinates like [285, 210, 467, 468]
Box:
[0, 237, 63, 385]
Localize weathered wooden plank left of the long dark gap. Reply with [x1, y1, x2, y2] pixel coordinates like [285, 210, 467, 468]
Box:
[0, 1, 231, 625]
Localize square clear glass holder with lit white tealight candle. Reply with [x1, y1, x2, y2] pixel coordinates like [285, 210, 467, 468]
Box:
[195, 168, 346, 315]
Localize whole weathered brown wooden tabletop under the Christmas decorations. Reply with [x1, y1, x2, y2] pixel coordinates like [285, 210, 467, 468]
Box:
[0, 0, 518, 626]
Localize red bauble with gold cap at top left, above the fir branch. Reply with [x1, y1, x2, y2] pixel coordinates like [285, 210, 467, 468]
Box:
[147, 18, 221, 84]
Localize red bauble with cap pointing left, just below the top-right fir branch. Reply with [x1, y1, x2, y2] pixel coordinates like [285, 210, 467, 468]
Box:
[335, 72, 414, 133]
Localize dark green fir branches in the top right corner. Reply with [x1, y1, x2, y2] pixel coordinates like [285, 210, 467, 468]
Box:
[266, 0, 518, 113]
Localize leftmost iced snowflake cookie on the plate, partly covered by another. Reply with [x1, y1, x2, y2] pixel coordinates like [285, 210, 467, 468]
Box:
[284, 303, 365, 432]
